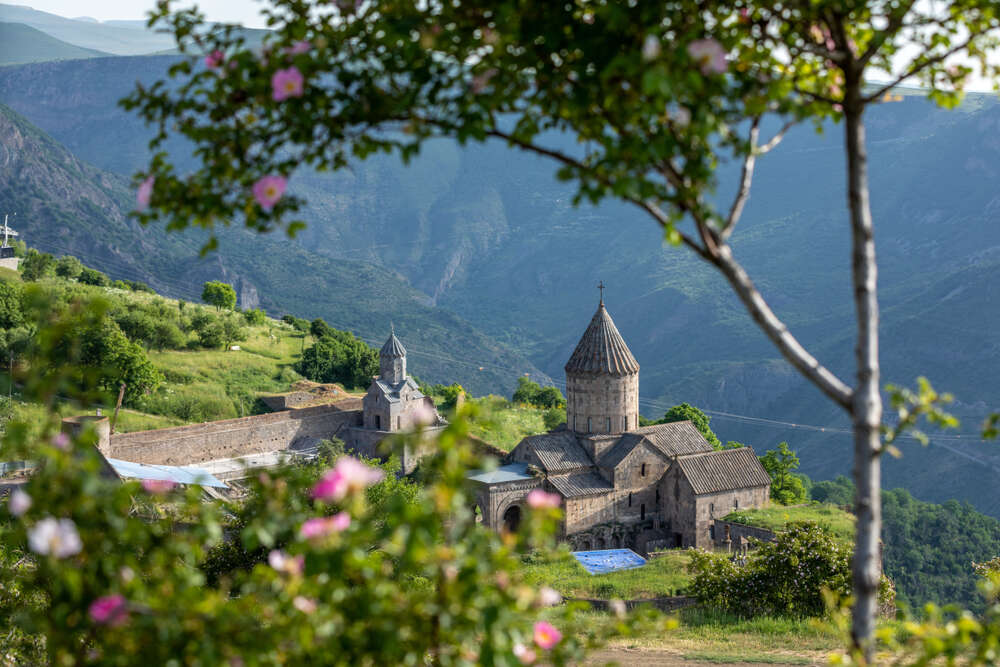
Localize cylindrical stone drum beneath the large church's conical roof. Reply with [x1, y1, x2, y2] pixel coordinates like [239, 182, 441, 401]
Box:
[566, 373, 639, 433]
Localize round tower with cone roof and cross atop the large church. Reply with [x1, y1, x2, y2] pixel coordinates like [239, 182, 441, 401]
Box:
[565, 282, 639, 434]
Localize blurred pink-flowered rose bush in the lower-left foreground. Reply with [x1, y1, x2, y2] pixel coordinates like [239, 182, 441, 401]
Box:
[0, 309, 664, 665]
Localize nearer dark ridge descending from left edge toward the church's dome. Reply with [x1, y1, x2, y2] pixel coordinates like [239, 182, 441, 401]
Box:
[0, 105, 538, 392]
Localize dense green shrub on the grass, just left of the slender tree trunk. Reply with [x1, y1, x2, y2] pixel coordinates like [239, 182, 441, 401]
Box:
[688, 522, 891, 616]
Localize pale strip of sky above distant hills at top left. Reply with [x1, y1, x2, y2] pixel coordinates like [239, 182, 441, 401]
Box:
[26, 0, 264, 28]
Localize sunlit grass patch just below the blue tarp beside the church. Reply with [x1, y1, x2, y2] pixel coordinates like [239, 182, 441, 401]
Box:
[522, 549, 690, 600]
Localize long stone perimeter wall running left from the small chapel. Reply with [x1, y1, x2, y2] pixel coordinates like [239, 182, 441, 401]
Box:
[108, 405, 361, 465]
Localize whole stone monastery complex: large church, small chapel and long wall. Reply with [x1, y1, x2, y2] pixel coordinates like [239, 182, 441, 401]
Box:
[64, 297, 771, 552]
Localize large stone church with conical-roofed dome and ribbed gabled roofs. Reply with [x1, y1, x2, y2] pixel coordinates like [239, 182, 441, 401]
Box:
[470, 297, 771, 552]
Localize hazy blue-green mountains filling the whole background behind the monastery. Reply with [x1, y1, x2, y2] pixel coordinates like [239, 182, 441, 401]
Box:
[0, 6, 1000, 516]
